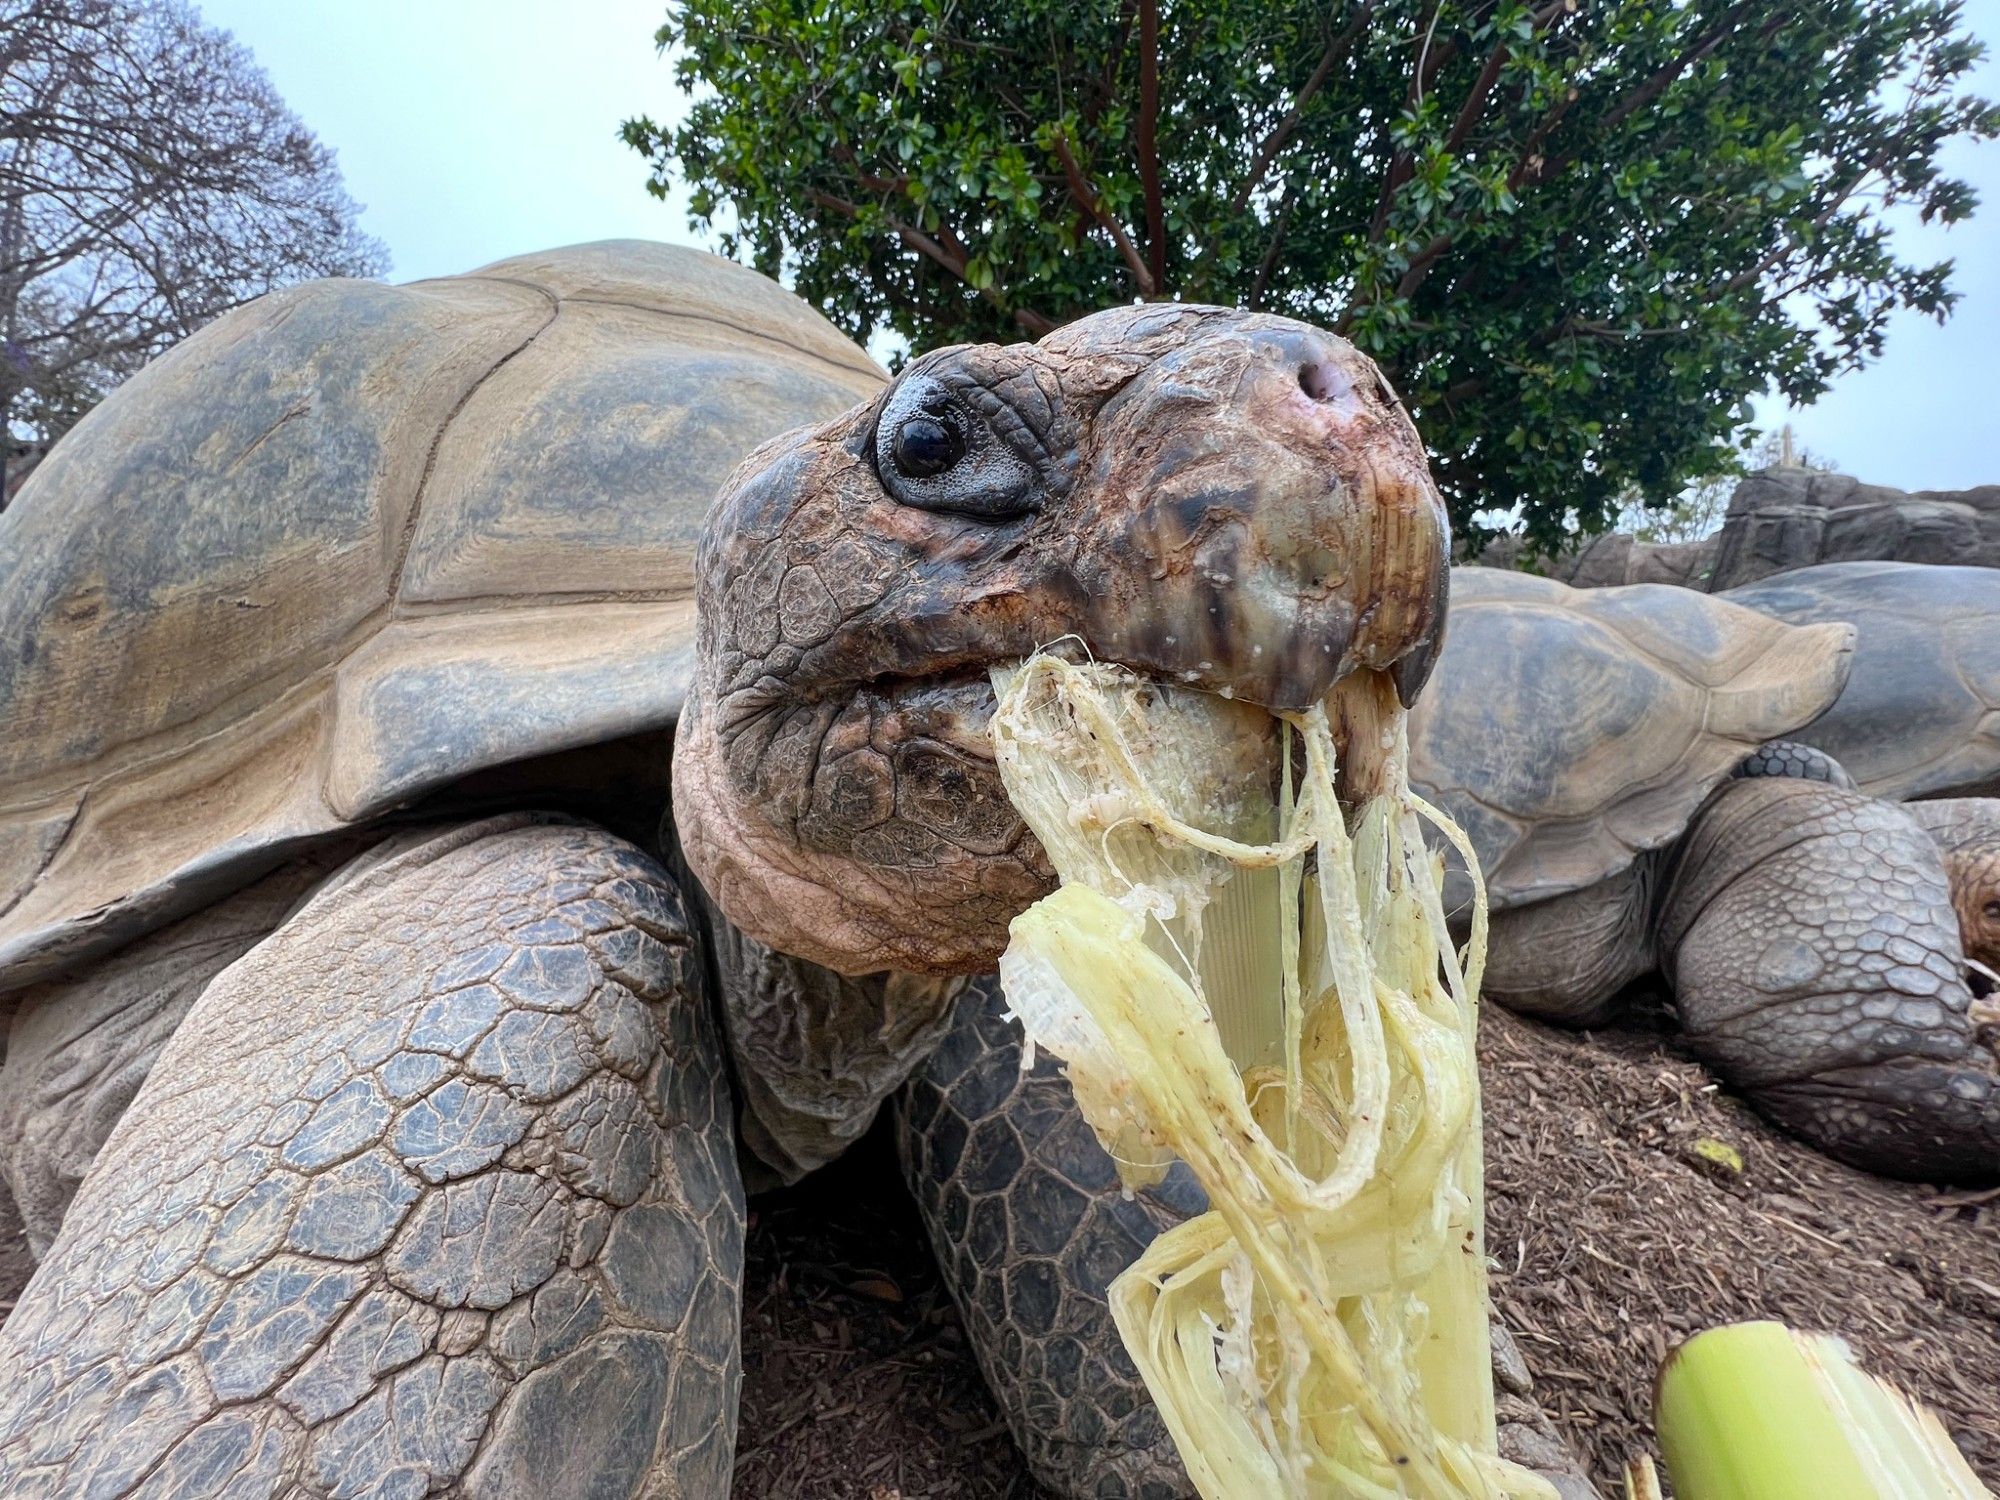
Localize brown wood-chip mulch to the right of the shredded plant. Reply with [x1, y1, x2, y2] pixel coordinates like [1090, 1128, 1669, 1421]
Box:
[1480, 1010, 2000, 1488]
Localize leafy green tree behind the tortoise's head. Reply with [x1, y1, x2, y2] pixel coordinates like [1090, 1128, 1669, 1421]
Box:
[624, 0, 2000, 544]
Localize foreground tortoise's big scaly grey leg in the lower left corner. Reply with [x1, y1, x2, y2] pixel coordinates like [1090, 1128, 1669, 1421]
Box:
[0, 816, 744, 1500]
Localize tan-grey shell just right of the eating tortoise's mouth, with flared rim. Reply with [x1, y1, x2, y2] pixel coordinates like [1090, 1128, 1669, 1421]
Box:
[1410, 568, 1854, 908]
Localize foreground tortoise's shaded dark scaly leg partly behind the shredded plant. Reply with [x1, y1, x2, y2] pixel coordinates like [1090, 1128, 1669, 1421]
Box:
[896, 978, 1208, 1500]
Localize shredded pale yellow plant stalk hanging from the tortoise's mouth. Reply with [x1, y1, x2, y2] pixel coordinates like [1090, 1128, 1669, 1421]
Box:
[994, 654, 1554, 1500]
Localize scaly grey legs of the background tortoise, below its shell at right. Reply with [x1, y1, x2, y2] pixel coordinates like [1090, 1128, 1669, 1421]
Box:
[1482, 740, 2000, 1182]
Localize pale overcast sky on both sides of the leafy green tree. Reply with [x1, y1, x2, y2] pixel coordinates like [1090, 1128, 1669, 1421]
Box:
[200, 0, 2000, 490]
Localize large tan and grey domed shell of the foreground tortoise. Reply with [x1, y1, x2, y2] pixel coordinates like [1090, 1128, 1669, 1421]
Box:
[0, 240, 884, 986]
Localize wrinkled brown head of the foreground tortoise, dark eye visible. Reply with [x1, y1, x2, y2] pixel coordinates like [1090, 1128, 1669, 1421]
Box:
[674, 306, 1448, 974]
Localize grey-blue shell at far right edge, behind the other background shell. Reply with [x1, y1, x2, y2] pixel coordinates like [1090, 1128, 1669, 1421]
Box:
[1720, 562, 2000, 800]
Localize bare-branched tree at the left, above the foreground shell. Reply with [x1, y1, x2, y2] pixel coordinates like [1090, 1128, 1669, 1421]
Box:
[0, 0, 386, 504]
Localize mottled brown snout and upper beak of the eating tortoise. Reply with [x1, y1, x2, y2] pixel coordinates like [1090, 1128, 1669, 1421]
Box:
[1072, 314, 1450, 712]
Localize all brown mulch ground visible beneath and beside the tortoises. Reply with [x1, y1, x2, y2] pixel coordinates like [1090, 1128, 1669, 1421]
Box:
[0, 1010, 2000, 1500]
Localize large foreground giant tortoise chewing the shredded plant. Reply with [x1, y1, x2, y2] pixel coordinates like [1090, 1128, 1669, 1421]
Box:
[0, 244, 1504, 1500]
